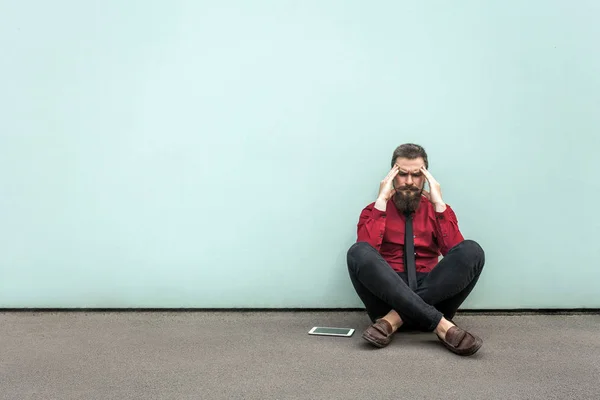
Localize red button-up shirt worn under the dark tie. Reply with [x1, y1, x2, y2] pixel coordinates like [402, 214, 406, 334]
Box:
[357, 196, 464, 272]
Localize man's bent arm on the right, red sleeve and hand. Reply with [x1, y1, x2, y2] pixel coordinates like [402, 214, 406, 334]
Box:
[421, 167, 465, 256]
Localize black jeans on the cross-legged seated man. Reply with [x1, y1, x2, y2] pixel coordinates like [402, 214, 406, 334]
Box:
[347, 240, 485, 332]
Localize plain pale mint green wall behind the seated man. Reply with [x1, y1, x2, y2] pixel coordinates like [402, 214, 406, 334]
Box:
[0, 0, 600, 308]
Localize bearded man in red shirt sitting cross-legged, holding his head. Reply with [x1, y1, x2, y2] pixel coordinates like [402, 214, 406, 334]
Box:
[347, 143, 485, 355]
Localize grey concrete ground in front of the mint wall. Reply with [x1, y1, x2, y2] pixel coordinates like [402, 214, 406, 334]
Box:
[0, 312, 600, 400]
